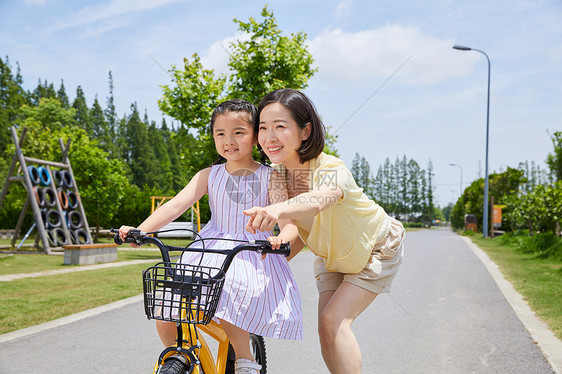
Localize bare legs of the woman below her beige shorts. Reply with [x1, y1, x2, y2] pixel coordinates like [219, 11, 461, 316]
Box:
[318, 282, 377, 374]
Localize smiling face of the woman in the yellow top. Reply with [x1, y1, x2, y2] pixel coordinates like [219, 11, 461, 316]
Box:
[258, 103, 310, 167]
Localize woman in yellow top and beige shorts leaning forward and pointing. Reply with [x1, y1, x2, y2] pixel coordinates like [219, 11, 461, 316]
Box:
[244, 89, 405, 373]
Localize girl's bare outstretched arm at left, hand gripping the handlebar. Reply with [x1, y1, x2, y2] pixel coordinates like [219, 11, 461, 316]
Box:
[119, 168, 211, 240]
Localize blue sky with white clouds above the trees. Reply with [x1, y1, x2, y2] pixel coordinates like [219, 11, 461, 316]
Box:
[0, 0, 562, 206]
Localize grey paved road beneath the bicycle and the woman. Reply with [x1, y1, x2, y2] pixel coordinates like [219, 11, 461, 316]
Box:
[0, 230, 553, 374]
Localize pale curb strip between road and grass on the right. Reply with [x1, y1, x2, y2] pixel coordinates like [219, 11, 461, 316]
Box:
[461, 236, 562, 374]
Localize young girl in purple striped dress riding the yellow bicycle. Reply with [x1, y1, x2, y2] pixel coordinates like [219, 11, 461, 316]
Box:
[119, 100, 302, 374]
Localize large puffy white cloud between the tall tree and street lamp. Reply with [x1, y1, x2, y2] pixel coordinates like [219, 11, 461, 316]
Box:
[310, 25, 478, 84]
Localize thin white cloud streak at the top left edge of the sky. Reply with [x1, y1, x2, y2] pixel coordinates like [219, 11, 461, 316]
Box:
[55, 0, 180, 28]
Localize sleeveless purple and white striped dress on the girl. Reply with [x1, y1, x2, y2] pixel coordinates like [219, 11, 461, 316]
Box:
[180, 164, 302, 339]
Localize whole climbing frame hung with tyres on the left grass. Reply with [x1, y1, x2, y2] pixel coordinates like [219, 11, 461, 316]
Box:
[0, 127, 92, 254]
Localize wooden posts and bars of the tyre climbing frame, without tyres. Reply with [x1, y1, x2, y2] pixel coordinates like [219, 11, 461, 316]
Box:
[0, 127, 93, 254]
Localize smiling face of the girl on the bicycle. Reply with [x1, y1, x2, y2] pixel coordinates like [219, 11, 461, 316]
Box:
[213, 112, 257, 162]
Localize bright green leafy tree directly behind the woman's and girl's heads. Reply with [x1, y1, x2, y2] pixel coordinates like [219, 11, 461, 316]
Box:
[158, 7, 320, 185]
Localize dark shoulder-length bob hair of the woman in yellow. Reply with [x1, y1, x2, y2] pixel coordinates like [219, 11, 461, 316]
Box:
[254, 88, 326, 163]
